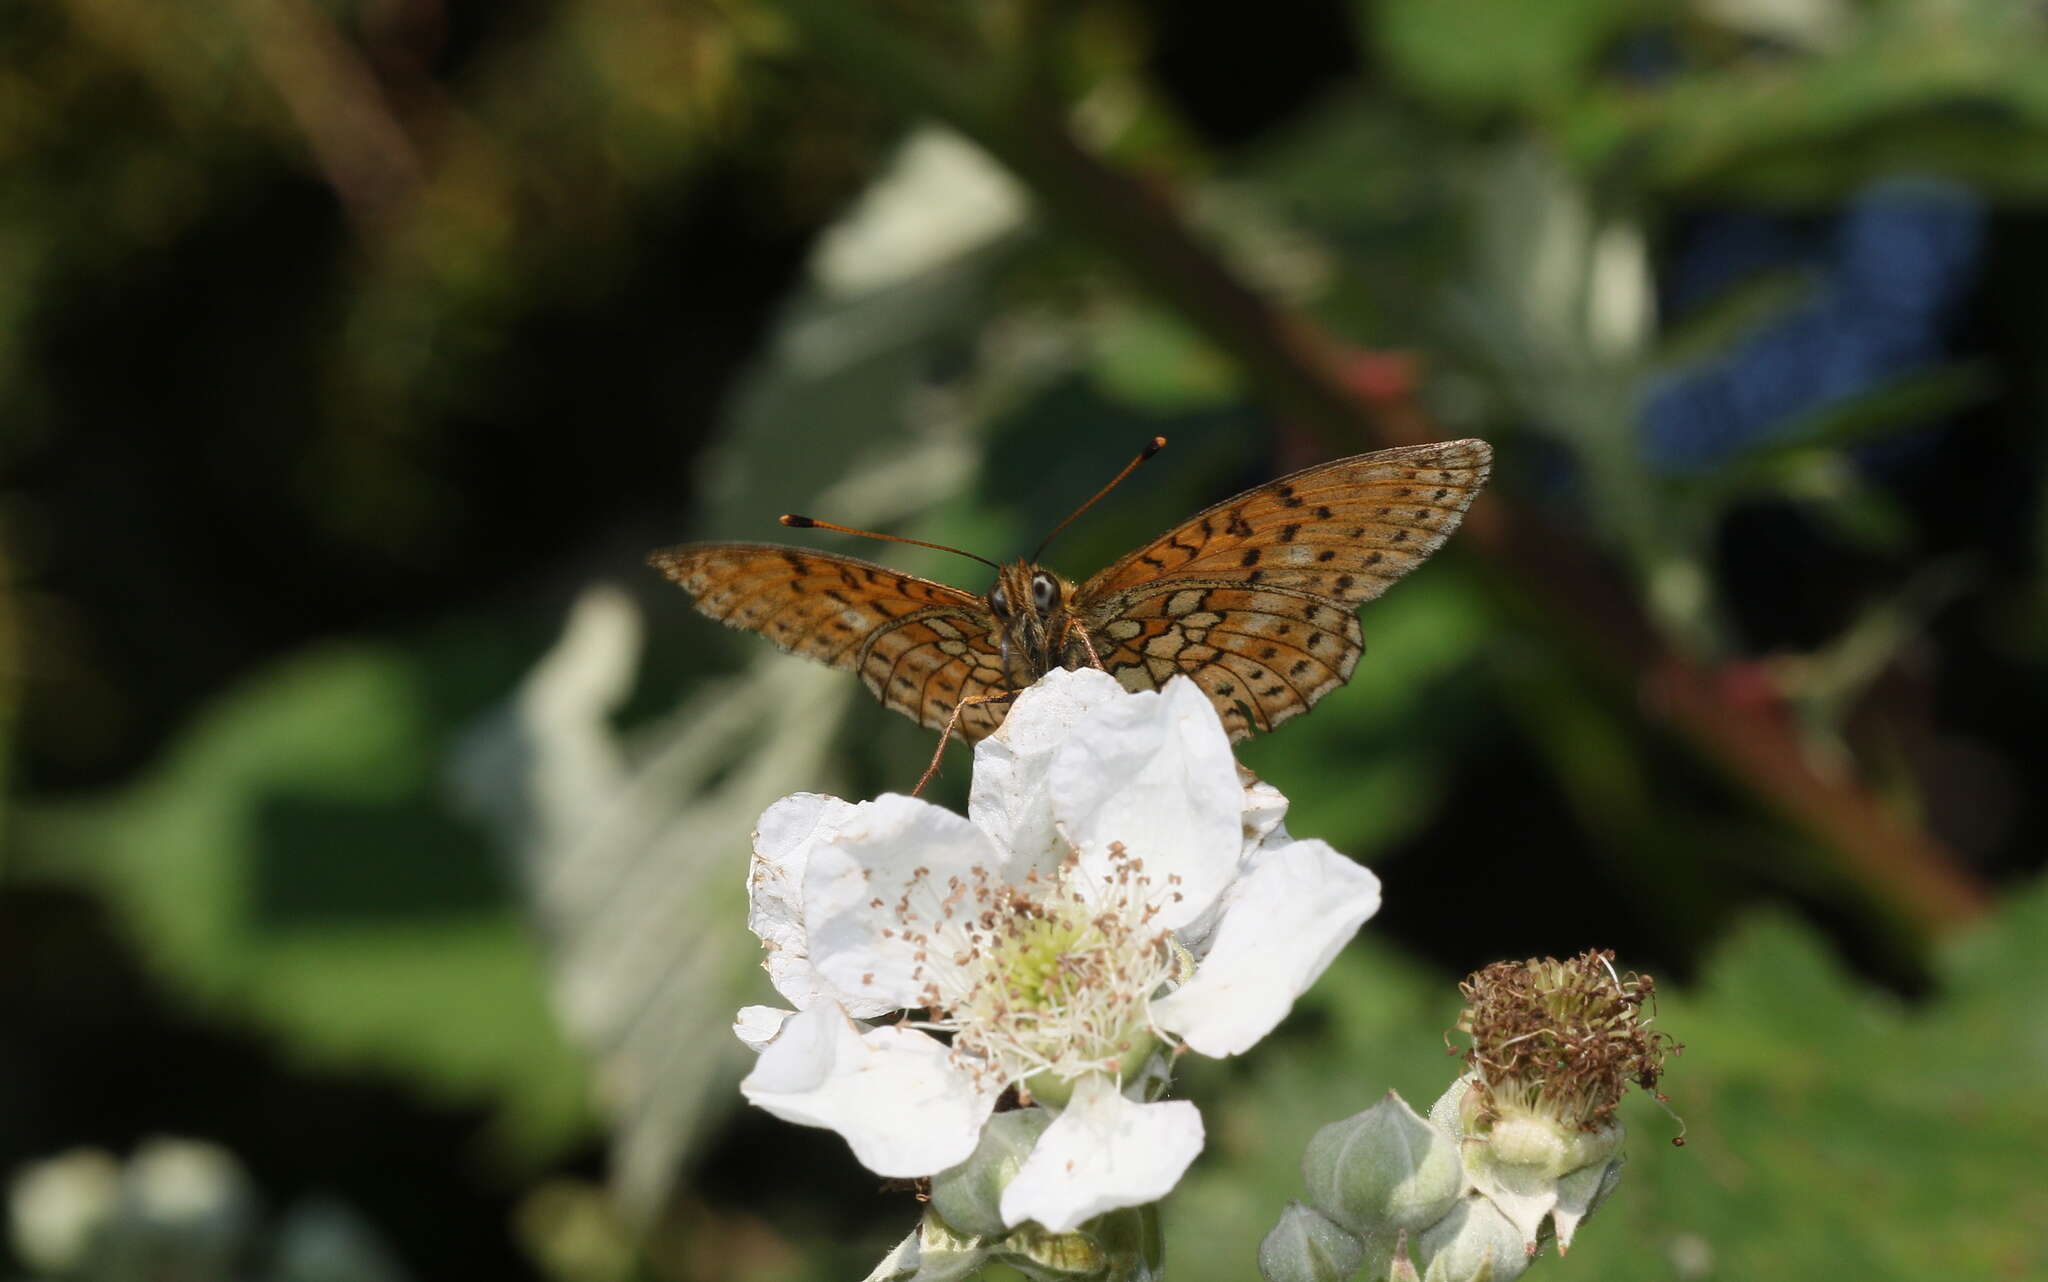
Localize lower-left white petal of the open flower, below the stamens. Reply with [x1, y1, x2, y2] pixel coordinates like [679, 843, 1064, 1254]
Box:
[739, 1006, 997, 1180]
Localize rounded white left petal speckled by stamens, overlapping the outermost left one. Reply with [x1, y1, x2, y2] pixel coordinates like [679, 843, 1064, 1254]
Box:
[803, 793, 1001, 1010]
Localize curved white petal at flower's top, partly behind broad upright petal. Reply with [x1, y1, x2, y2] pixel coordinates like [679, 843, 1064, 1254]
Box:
[967, 668, 1128, 872]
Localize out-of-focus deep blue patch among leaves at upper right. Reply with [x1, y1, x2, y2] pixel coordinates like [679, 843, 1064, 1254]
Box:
[1642, 178, 1985, 473]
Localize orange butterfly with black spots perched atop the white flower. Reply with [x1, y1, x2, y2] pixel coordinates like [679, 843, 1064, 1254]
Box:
[647, 438, 1493, 761]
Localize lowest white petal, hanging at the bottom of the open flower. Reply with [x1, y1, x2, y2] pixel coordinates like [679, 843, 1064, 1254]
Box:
[1001, 1073, 1202, 1233]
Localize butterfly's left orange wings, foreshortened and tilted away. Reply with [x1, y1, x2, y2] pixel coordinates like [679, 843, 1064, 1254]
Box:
[647, 543, 1008, 739]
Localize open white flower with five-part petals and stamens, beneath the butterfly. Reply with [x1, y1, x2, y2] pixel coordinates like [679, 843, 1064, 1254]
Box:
[735, 670, 1380, 1233]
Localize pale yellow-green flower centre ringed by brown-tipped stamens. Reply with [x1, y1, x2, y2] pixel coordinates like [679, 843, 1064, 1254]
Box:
[895, 844, 1176, 1083]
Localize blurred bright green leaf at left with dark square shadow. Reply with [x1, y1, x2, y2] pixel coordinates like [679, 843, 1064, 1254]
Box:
[23, 635, 586, 1149]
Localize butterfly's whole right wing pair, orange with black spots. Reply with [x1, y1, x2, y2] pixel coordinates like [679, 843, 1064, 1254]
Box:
[1075, 440, 1493, 739]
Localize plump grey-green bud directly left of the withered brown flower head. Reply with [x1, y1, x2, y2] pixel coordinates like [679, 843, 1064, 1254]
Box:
[1300, 1092, 1462, 1237]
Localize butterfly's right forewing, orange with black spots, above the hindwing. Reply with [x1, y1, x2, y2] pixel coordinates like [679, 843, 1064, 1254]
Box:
[1079, 440, 1493, 606]
